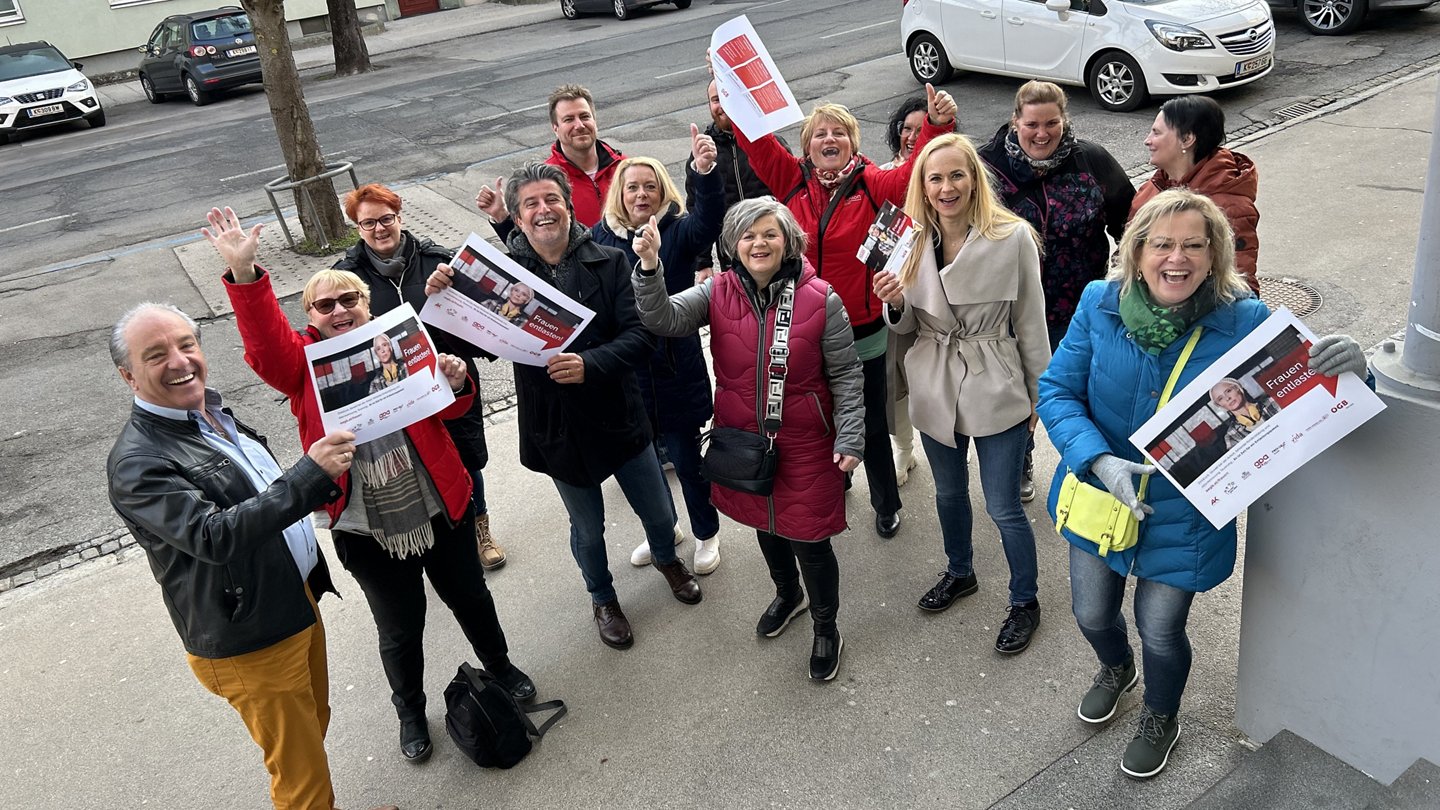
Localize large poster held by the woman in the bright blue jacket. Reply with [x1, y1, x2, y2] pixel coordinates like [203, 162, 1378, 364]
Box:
[1130, 307, 1385, 528]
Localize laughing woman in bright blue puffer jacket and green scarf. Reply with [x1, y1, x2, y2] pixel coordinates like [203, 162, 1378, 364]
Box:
[1038, 189, 1367, 778]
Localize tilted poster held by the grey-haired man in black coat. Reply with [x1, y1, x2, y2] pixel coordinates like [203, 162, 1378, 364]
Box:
[420, 233, 595, 366]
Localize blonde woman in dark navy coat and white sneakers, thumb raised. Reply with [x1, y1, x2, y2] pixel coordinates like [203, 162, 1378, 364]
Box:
[590, 124, 724, 574]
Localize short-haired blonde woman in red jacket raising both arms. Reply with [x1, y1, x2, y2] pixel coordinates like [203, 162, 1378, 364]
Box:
[736, 85, 955, 538]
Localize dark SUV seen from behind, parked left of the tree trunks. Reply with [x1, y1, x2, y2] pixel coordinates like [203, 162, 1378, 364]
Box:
[140, 6, 261, 107]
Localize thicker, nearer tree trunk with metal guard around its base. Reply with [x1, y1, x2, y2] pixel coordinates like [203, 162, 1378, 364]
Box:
[240, 0, 346, 245]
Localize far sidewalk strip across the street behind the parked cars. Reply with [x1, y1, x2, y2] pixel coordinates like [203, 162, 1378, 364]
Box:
[95, 0, 563, 107]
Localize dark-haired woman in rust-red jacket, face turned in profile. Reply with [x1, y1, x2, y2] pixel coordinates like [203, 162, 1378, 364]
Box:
[1130, 95, 1260, 294]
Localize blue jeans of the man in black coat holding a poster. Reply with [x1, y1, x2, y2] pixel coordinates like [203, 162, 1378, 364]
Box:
[552, 444, 675, 604]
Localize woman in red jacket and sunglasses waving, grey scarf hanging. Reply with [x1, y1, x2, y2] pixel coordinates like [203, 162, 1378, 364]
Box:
[203, 209, 536, 762]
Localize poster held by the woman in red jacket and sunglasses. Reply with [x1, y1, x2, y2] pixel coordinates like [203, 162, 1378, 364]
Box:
[305, 304, 455, 444]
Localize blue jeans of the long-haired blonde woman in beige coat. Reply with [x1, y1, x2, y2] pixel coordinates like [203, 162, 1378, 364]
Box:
[920, 422, 1040, 605]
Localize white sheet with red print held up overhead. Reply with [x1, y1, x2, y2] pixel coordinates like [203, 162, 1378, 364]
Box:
[710, 14, 805, 141]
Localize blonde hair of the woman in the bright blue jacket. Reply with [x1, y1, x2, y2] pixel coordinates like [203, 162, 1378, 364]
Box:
[1104, 189, 1250, 304]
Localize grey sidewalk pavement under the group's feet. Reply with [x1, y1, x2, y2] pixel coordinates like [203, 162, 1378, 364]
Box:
[0, 59, 1437, 810]
